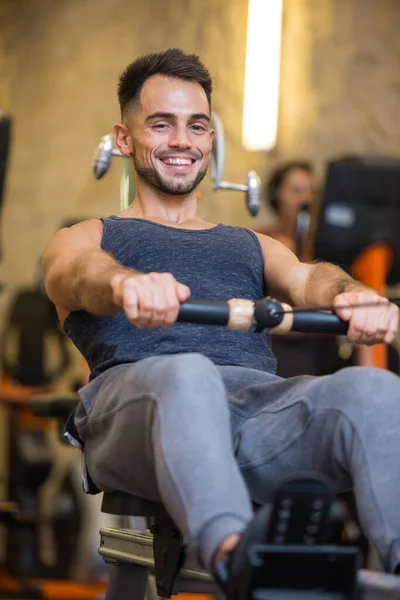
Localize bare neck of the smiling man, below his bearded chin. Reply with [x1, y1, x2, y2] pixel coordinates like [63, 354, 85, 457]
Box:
[124, 177, 199, 224]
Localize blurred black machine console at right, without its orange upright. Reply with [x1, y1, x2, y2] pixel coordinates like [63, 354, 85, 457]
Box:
[315, 156, 400, 284]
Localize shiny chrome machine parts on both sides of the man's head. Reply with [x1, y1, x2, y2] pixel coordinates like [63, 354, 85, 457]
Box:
[93, 112, 261, 217]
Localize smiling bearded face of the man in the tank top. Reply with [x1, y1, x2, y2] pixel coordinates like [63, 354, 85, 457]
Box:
[127, 75, 214, 195]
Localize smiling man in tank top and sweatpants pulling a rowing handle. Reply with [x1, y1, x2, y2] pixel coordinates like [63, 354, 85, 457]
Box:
[43, 49, 400, 592]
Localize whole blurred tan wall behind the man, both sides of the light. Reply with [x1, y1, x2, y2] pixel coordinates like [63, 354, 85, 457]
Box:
[0, 0, 400, 298]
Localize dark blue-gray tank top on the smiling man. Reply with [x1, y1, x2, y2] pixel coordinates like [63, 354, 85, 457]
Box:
[64, 216, 276, 380]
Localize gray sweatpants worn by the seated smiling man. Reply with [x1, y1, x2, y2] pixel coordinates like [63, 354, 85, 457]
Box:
[76, 354, 400, 570]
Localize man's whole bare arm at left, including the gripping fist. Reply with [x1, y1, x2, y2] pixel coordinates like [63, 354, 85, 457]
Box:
[43, 220, 190, 327]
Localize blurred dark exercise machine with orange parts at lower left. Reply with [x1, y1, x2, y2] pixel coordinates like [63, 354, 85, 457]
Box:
[0, 289, 80, 593]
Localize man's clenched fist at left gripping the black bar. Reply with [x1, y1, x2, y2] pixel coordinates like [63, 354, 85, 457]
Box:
[111, 273, 190, 327]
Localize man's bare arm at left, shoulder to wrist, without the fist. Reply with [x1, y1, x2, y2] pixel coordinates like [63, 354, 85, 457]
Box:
[43, 219, 137, 316]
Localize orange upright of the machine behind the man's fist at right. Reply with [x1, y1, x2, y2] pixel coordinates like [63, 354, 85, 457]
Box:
[351, 244, 393, 369]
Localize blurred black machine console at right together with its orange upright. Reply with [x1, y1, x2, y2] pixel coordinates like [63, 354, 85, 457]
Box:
[314, 156, 400, 368]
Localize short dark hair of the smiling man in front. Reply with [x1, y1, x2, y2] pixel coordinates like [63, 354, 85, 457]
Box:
[118, 48, 212, 116]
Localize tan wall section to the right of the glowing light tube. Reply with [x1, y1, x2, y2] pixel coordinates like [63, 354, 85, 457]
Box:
[279, 0, 400, 165]
